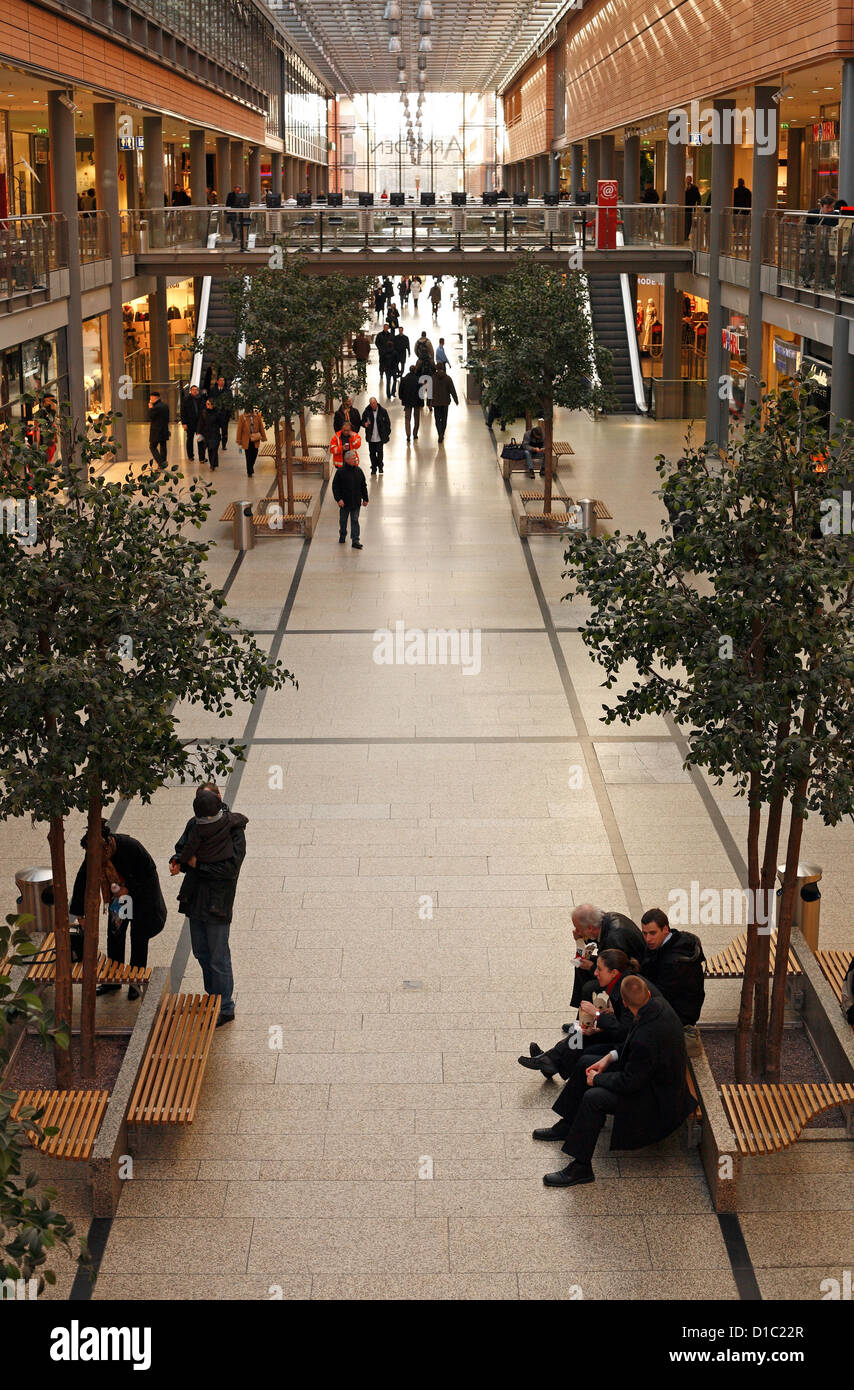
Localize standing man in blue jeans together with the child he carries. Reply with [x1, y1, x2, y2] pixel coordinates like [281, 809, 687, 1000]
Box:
[170, 787, 248, 1027]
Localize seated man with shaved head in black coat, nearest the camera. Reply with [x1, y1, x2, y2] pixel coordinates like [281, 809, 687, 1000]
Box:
[534, 974, 697, 1187]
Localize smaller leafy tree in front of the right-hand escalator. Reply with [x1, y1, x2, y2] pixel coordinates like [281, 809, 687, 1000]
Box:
[463, 252, 613, 512]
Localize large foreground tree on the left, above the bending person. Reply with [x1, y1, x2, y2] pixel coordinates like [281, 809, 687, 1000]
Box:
[0, 410, 292, 1084]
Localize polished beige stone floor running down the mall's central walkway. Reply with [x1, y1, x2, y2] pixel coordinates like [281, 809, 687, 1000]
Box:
[0, 282, 854, 1300]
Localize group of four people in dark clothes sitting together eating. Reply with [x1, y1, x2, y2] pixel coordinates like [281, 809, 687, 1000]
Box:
[519, 904, 705, 1187]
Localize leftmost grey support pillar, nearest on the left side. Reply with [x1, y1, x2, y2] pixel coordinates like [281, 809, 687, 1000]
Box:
[47, 90, 86, 430]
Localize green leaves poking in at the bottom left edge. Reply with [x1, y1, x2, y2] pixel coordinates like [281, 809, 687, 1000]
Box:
[0, 916, 90, 1293]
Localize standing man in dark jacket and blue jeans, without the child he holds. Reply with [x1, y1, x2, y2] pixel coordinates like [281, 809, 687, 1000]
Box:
[170, 785, 246, 1027]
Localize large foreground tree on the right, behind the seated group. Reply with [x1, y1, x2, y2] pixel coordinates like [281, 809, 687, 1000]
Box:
[567, 381, 854, 1081]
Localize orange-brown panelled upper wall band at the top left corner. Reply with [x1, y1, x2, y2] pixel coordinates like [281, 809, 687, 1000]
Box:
[0, 0, 266, 145]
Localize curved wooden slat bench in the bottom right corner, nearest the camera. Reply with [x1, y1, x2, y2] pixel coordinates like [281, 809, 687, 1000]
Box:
[720, 1081, 854, 1156]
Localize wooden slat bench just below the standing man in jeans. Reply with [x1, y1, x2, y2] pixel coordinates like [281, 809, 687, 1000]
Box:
[128, 994, 221, 1125]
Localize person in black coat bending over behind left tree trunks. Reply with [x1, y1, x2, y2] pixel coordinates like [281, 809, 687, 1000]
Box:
[68, 820, 167, 999]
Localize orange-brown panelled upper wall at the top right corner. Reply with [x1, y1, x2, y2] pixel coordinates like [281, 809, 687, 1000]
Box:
[561, 0, 854, 147]
